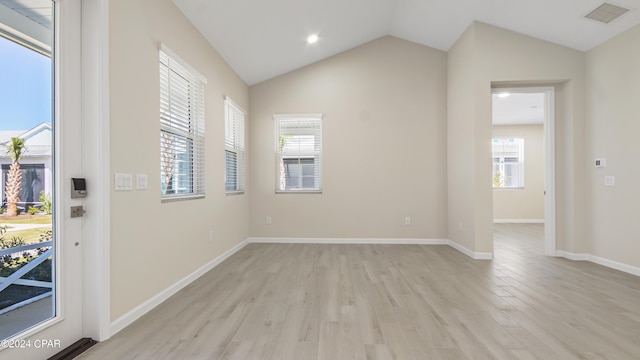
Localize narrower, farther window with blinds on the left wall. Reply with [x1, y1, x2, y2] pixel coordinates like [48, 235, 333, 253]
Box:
[224, 97, 245, 193]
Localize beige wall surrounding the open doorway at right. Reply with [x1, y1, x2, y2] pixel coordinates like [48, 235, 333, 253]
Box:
[447, 22, 585, 253]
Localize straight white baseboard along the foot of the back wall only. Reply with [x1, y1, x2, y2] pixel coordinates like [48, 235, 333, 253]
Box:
[248, 237, 449, 245]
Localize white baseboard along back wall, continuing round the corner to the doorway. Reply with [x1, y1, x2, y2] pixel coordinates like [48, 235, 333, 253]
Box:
[249, 237, 493, 260]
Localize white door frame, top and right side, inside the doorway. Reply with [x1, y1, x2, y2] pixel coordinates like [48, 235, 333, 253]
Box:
[491, 83, 557, 256]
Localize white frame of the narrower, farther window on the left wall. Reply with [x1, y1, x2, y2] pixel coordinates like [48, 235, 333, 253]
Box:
[224, 96, 246, 195]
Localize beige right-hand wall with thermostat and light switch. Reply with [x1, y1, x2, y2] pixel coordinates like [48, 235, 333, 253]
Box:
[584, 22, 640, 269]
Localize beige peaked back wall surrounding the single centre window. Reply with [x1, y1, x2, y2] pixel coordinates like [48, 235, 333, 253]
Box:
[250, 36, 447, 239]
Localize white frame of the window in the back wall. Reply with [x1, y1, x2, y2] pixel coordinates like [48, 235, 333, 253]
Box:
[273, 113, 323, 194]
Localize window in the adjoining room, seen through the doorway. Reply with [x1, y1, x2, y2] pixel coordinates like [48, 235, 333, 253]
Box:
[492, 139, 524, 188]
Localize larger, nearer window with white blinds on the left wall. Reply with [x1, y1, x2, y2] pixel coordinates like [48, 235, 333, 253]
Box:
[160, 45, 206, 200]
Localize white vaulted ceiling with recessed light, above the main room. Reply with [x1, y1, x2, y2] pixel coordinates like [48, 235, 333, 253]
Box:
[173, 0, 640, 85]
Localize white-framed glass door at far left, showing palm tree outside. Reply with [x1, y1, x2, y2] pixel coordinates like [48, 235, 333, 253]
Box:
[0, 0, 82, 359]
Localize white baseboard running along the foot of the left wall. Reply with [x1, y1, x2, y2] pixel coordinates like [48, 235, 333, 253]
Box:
[111, 240, 249, 336]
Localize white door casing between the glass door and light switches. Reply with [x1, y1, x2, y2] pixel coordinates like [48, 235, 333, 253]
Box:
[79, 0, 112, 341]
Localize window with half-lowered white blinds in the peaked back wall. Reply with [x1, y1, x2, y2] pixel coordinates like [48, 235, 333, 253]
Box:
[274, 114, 322, 192]
